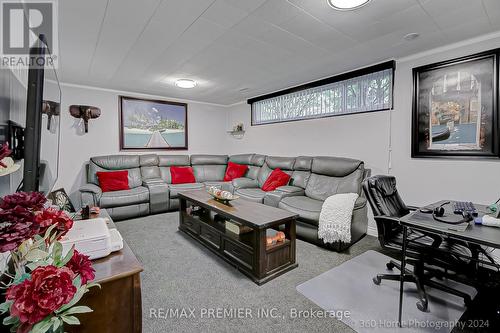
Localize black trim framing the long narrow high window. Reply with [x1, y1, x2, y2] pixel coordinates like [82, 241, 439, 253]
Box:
[247, 60, 396, 126]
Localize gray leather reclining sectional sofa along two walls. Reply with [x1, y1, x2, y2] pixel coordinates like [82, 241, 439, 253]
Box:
[80, 154, 369, 251]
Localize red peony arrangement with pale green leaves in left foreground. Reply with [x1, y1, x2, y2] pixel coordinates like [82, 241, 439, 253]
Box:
[0, 191, 96, 333]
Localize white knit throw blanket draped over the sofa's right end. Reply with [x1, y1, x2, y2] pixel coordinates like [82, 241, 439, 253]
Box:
[318, 193, 359, 243]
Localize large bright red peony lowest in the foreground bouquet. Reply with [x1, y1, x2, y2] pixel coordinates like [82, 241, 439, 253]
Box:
[6, 265, 77, 324]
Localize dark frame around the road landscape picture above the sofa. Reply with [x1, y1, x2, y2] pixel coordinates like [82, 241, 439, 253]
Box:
[118, 96, 188, 151]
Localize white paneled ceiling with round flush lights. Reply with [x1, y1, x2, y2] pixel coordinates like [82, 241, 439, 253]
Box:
[59, 0, 500, 104]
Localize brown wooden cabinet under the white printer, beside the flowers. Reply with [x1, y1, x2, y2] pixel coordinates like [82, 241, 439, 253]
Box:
[64, 209, 142, 333]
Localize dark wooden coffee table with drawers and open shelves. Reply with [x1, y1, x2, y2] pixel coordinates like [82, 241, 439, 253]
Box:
[179, 190, 298, 285]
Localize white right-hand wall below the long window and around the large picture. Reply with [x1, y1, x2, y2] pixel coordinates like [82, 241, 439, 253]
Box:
[228, 34, 500, 233]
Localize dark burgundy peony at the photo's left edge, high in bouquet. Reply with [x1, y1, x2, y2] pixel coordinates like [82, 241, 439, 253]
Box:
[0, 206, 39, 252]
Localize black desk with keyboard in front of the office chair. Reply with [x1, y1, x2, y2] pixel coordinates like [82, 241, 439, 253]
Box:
[398, 200, 500, 325]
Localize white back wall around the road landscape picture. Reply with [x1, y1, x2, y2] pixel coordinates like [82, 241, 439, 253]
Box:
[55, 85, 228, 204]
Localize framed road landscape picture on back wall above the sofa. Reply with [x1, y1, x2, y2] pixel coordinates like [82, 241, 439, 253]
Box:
[119, 96, 188, 150]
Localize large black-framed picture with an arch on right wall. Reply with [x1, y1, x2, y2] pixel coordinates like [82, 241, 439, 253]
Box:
[412, 50, 500, 158]
